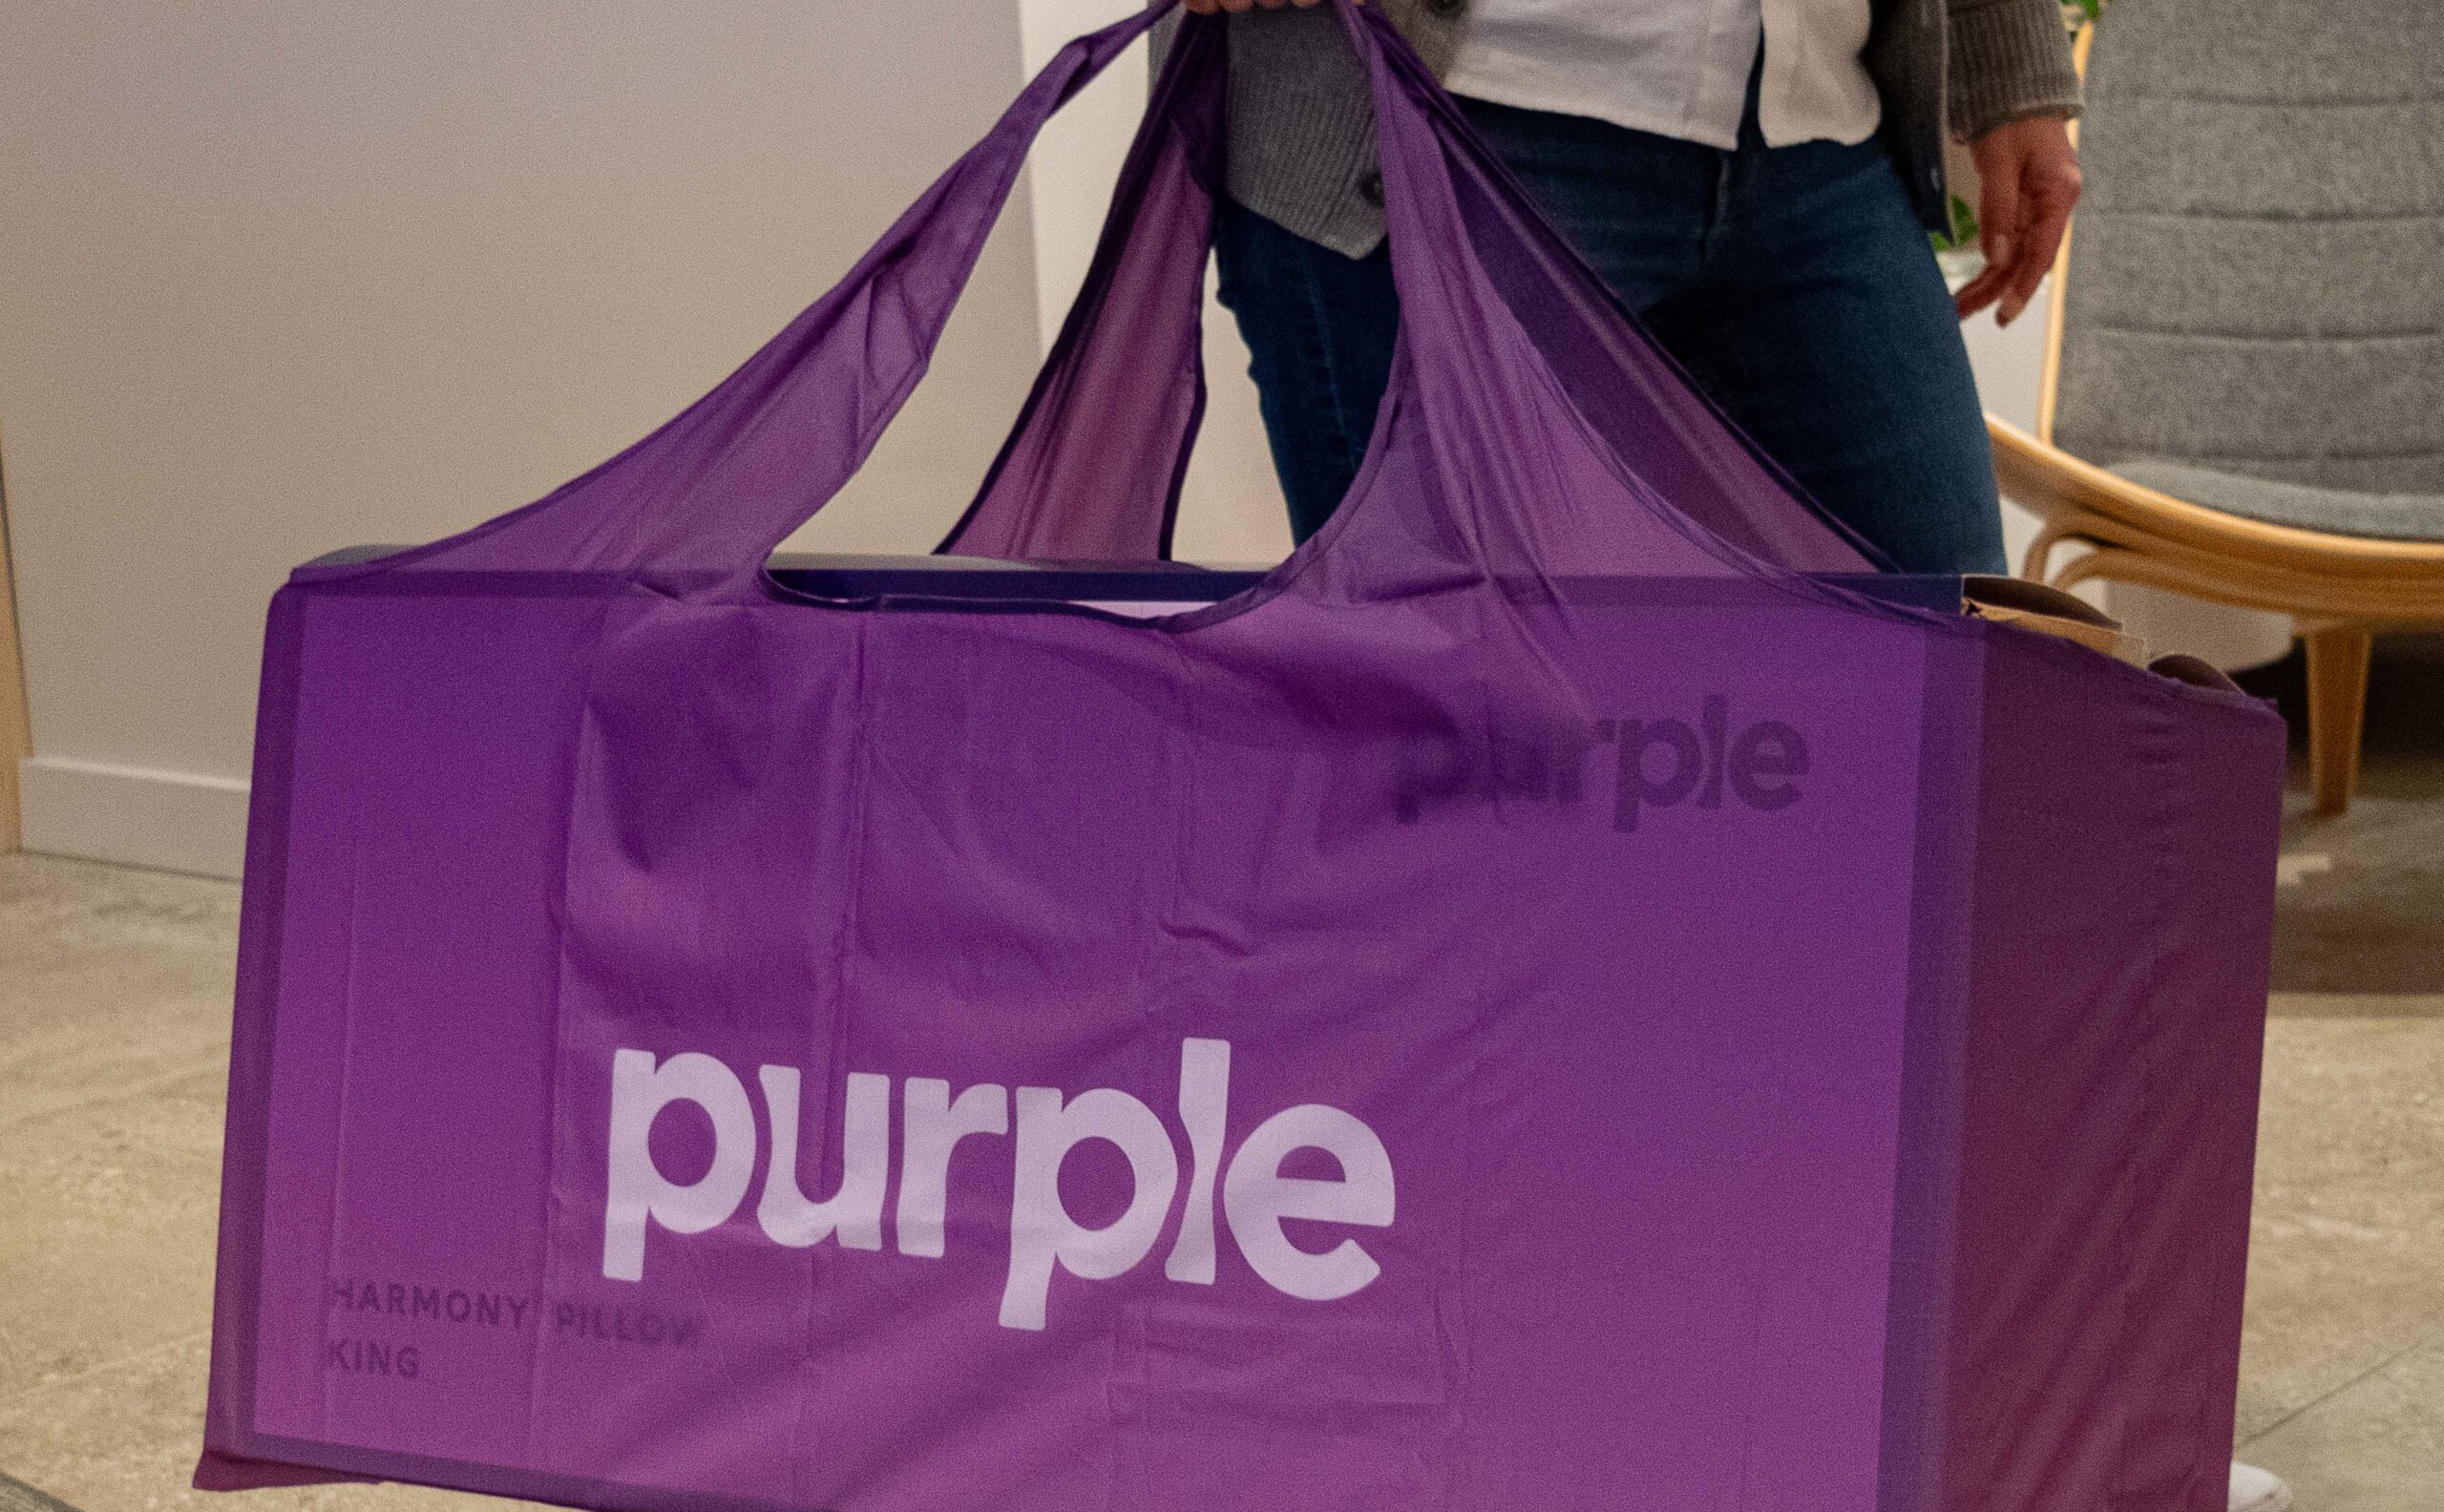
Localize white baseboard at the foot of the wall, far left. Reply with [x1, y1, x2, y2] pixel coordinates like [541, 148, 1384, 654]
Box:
[17, 755, 247, 877]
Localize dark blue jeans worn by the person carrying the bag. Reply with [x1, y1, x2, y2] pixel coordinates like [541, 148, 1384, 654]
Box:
[1214, 100, 2004, 572]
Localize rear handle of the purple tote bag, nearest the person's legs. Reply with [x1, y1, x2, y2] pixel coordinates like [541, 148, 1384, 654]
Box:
[941, 8, 1886, 583]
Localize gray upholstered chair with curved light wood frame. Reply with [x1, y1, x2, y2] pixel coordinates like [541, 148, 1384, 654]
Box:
[1990, 0, 2444, 813]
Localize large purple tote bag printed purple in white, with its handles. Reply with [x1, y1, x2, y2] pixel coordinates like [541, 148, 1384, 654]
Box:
[198, 5, 2283, 1512]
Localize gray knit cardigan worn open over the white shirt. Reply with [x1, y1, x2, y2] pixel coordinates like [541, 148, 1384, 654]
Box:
[1172, 0, 2080, 257]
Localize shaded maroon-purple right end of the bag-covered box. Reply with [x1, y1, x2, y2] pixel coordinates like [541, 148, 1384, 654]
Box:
[1936, 638, 2283, 1512]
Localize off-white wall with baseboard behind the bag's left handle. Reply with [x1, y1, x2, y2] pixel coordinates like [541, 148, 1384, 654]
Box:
[0, 0, 1036, 872]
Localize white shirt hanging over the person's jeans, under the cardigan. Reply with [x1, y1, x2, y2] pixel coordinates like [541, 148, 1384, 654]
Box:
[1447, 0, 1882, 147]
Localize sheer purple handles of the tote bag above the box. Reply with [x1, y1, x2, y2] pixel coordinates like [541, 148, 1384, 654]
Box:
[315, 0, 1865, 601]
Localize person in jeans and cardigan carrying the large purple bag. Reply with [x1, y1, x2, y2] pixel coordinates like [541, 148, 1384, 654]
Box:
[1186, 0, 2290, 1512]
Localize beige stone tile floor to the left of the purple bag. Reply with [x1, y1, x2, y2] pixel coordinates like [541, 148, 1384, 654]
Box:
[0, 855, 533, 1512]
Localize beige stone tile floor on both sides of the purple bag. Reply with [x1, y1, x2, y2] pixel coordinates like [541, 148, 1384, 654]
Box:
[0, 857, 2444, 1512]
